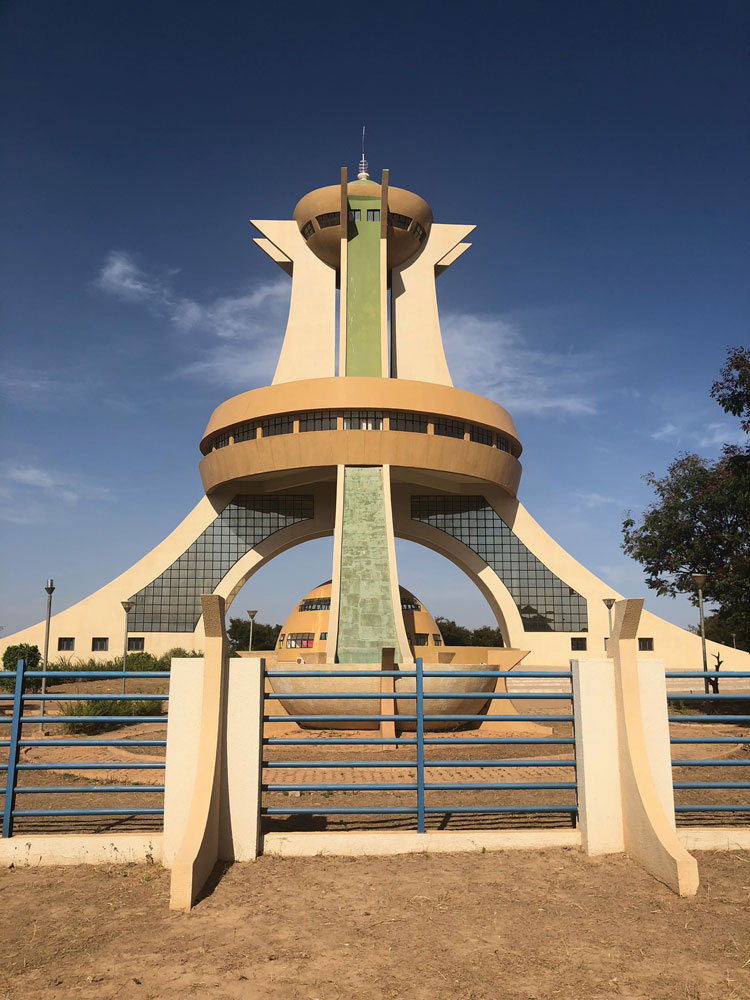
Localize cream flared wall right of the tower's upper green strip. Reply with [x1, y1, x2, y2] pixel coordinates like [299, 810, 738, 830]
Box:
[391, 223, 474, 386]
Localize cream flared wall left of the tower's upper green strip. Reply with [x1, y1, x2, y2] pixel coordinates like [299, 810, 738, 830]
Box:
[253, 220, 336, 385]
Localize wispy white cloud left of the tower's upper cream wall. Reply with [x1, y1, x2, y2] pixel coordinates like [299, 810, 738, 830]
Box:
[95, 250, 291, 385]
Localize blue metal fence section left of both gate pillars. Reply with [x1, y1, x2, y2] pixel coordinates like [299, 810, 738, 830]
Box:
[0, 660, 170, 837]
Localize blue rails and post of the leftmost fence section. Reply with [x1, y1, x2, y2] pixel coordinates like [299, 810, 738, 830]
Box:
[0, 660, 170, 837]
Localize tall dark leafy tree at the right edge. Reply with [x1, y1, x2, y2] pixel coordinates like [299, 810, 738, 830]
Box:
[622, 347, 750, 645]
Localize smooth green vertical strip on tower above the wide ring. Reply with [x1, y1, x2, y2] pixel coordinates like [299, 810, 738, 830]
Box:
[345, 181, 384, 378]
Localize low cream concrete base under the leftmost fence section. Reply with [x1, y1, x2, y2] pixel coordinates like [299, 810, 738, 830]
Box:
[0, 833, 162, 868]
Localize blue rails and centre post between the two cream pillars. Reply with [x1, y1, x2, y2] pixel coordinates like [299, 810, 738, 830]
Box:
[262, 659, 578, 833]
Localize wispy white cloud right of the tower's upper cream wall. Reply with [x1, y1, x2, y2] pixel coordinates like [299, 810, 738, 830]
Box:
[441, 313, 602, 417]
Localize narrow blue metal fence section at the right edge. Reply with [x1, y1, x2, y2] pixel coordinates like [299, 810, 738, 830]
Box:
[667, 670, 750, 825]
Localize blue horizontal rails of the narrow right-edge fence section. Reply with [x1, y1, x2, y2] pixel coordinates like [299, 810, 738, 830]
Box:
[667, 670, 750, 817]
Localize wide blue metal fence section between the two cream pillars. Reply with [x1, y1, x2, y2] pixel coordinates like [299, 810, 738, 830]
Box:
[261, 659, 578, 833]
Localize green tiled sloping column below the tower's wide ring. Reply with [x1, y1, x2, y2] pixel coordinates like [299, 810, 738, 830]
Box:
[337, 466, 399, 663]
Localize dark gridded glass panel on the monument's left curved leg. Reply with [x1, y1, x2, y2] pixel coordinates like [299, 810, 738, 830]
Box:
[128, 496, 314, 632]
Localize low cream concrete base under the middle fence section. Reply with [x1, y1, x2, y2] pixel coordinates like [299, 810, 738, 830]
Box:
[262, 830, 581, 858]
